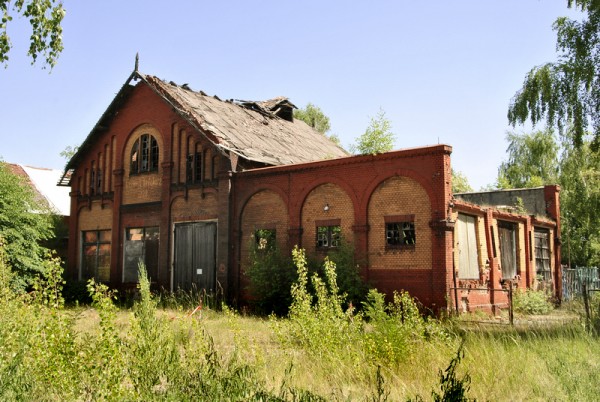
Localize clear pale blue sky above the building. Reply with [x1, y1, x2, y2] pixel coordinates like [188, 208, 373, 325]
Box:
[0, 0, 576, 189]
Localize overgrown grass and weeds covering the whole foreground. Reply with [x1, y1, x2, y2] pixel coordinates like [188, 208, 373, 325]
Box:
[0, 250, 600, 401]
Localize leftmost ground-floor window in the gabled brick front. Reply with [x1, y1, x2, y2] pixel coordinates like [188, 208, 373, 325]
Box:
[79, 230, 111, 282]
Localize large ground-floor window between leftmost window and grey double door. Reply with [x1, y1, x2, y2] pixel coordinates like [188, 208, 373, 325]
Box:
[123, 226, 160, 283]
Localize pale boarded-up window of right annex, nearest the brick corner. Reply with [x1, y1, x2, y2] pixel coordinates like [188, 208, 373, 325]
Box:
[454, 214, 479, 279]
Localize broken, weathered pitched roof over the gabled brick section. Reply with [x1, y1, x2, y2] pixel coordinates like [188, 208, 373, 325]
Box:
[61, 71, 348, 184]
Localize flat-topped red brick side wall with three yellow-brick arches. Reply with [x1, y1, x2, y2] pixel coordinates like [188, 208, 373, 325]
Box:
[232, 145, 452, 309]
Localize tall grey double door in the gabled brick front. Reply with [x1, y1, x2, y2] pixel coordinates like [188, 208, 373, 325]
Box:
[173, 222, 217, 292]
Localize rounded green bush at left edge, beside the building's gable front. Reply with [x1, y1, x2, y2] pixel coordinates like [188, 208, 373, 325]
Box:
[0, 161, 52, 290]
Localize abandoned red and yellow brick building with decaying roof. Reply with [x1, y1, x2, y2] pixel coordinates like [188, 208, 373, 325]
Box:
[60, 68, 560, 309]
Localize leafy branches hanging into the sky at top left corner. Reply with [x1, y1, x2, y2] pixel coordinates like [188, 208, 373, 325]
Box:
[0, 0, 65, 67]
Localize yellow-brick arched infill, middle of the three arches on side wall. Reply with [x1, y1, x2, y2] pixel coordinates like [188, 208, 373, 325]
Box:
[299, 180, 356, 254]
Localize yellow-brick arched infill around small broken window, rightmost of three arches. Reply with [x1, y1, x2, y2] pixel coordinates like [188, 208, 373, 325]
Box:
[366, 175, 433, 269]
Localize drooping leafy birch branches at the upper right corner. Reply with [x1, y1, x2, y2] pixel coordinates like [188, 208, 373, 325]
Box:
[508, 0, 600, 150]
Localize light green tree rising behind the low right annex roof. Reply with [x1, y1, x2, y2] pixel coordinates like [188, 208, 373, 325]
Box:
[498, 130, 559, 189]
